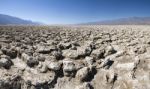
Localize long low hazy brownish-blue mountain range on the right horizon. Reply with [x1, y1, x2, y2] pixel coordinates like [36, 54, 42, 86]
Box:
[83, 17, 150, 25]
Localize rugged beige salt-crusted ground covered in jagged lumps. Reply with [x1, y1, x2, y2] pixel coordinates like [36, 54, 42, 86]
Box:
[0, 25, 150, 89]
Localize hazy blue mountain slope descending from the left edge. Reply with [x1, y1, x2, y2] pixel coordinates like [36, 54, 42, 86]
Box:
[0, 14, 40, 25]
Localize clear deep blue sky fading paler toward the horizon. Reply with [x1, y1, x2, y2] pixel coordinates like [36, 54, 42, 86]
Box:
[0, 0, 150, 24]
